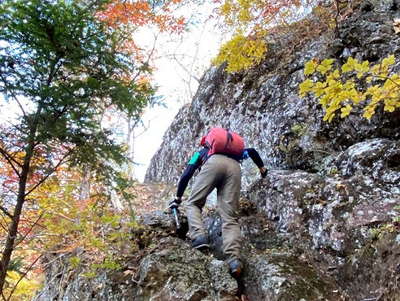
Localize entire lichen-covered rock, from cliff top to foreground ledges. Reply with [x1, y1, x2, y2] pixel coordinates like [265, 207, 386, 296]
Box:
[36, 0, 400, 301]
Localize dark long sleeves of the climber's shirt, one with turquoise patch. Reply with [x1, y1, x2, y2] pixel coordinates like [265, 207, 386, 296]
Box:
[176, 147, 264, 198]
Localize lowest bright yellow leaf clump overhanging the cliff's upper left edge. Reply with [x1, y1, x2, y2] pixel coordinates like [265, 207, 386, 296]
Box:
[213, 33, 267, 72]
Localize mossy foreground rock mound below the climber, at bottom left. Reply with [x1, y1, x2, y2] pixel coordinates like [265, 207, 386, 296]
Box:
[34, 216, 238, 301]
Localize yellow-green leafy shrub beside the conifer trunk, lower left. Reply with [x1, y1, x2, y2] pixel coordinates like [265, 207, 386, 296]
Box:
[27, 170, 138, 269]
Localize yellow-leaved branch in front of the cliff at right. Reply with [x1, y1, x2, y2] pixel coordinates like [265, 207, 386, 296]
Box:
[299, 55, 400, 122]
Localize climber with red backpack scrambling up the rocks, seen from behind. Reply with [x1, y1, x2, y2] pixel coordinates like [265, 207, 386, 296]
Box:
[169, 128, 267, 278]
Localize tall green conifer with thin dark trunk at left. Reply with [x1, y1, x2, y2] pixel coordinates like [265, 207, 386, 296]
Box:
[0, 0, 153, 296]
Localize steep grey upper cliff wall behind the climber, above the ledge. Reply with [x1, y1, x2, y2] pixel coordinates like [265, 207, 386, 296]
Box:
[146, 1, 400, 188]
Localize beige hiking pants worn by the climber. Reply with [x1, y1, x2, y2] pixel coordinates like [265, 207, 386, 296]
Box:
[186, 154, 241, 258]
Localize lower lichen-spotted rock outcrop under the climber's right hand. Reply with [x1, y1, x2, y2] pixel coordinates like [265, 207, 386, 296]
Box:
[241, 139, 400, 300]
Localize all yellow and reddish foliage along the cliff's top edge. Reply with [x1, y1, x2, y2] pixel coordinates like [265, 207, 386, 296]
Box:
[213, 0, 359, 73]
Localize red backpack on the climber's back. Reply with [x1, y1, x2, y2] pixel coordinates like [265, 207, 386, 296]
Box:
[205, 128, 244, 158]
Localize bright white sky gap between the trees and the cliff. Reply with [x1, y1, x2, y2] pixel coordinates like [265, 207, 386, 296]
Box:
[135, 8, 223, 181]
